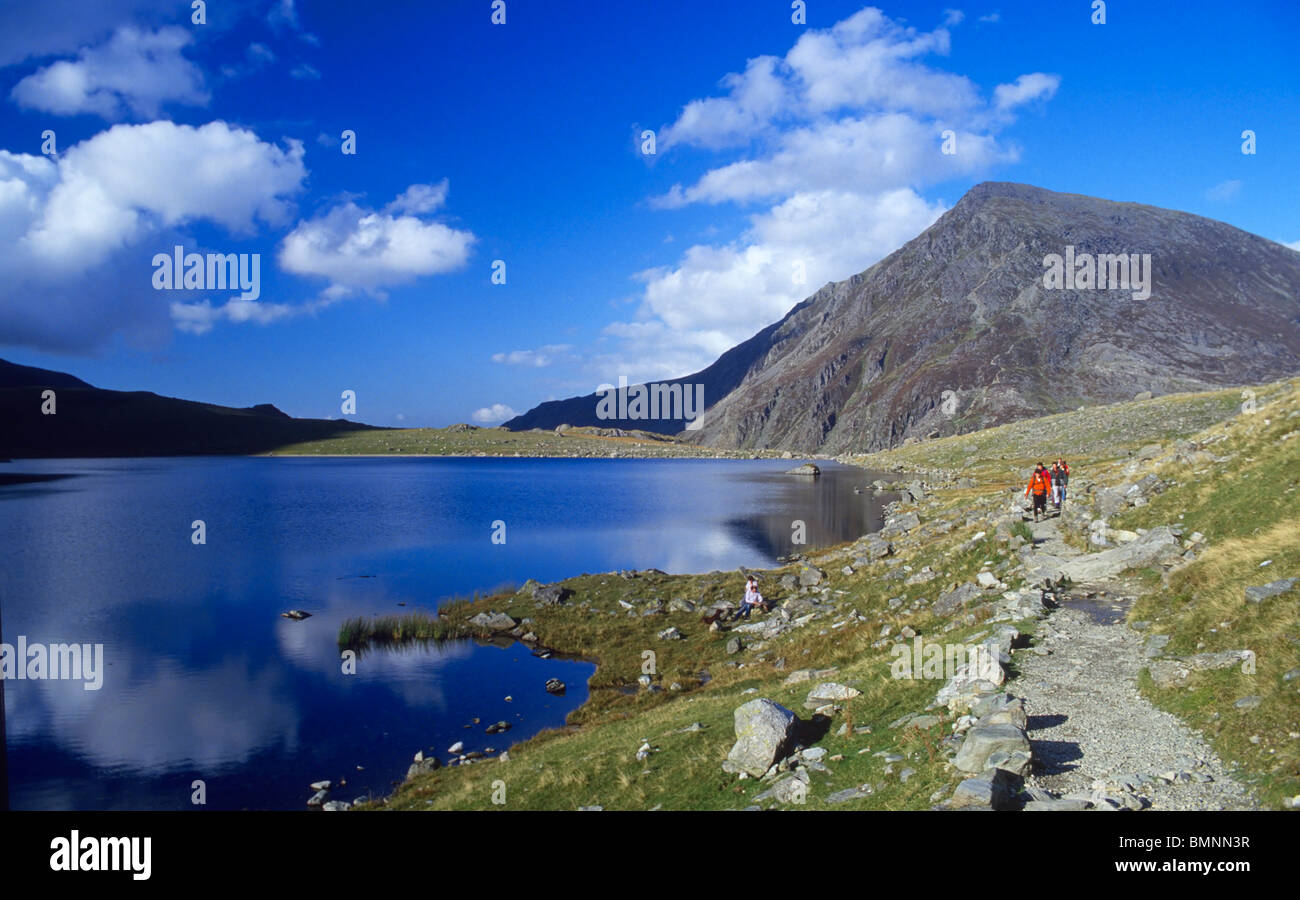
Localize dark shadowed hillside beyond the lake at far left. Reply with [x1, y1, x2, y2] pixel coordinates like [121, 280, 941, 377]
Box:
[0, 360, 374, 459]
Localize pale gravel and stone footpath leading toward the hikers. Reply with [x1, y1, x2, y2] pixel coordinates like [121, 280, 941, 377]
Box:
[1008, 519, 1258, 810]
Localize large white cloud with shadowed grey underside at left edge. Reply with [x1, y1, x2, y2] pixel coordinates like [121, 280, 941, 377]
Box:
[0, 122, 307, 350]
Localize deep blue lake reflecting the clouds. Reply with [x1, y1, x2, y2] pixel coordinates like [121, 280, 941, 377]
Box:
[0, 458, 880, 809]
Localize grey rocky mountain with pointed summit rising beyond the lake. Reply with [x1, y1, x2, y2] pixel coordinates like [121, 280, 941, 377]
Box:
[507, 182, 1300, 453]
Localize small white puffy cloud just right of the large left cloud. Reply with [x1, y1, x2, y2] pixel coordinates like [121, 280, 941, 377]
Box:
[280, 182, 477, 298]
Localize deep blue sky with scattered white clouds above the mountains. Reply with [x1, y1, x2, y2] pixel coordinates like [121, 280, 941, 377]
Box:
[0, 0, 1300, 425]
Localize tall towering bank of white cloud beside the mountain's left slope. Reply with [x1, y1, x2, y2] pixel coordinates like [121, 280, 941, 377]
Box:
[593, 9, 1060, 381]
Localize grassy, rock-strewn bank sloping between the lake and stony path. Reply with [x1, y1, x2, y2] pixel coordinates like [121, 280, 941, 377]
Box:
[353, 384, 1300, 809]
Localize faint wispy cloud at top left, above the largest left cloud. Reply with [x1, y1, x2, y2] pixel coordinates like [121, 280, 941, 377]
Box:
[10, 26, 209, 120]
